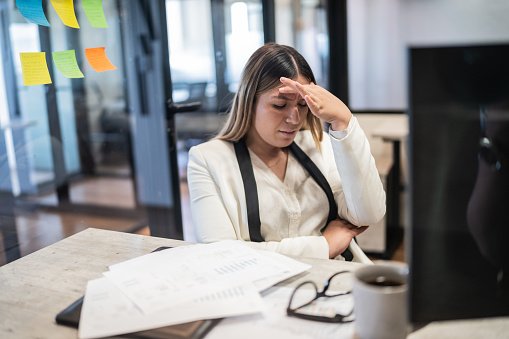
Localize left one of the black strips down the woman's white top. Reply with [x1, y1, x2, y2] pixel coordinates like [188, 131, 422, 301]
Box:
[233, 139, 263, 242]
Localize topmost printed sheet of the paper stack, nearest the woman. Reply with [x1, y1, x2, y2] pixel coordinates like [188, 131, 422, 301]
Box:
[104, 241, 310, 314]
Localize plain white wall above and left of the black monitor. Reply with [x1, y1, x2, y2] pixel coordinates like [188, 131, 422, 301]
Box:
[348, 0, 509, 110]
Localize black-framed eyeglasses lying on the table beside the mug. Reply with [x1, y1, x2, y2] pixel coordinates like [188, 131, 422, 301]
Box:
[286, 271, 353, 323]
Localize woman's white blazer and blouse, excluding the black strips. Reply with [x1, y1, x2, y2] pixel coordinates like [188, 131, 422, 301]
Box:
[188, 117, 385, 259]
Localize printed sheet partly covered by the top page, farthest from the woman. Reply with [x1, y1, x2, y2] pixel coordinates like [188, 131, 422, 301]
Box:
[79, 278, 264, 339]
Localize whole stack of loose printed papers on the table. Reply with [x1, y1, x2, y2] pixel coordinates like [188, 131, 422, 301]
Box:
[79, 240, 310, 339]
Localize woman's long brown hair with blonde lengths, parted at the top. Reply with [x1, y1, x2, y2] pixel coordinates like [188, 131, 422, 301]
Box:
[216, 43, 323, 150]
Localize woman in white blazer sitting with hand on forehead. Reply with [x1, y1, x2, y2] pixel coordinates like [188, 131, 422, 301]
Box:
[188, 43, 385, 258]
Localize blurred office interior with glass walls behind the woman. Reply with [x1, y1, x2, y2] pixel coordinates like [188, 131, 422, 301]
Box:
[0, 0, 509, 264]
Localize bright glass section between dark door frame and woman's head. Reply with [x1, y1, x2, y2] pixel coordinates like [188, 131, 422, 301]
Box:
[166, 0, 264, 112]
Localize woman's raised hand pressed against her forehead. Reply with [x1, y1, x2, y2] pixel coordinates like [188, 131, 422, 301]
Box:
[279, 77, 352, 131]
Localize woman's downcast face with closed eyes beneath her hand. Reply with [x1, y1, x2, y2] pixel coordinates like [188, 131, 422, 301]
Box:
[248, 75, 309, 148]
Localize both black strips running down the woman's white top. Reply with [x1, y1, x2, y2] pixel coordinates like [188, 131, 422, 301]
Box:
[233, 139, 353, 261]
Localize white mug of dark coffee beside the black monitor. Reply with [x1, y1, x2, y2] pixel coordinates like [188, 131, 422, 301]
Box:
[353, 262, 408, 339]
